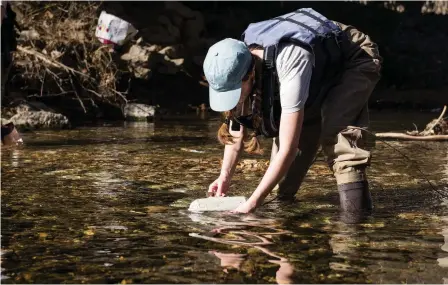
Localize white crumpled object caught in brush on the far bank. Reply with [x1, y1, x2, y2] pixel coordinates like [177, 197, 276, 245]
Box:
[95, 11, 138, 46]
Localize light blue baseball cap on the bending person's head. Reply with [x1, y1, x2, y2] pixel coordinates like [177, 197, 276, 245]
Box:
[203, 38, 252, 112]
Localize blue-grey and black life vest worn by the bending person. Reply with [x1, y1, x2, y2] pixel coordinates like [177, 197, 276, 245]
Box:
[235, 8, 343, 138]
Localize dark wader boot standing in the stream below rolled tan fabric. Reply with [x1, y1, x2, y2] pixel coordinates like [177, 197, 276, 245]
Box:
[338, 181, 373, 224]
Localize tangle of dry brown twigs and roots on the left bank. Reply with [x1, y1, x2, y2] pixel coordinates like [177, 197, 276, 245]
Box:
[8, 1, 131, 113]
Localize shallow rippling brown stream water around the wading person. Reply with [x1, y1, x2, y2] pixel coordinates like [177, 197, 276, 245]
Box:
[1, 111, 448, 284]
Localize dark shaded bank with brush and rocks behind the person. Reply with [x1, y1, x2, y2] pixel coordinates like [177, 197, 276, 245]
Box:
[2, 1, 448, 125]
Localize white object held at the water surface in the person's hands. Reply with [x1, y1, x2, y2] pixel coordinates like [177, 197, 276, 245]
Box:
[188, 196, 246, 212]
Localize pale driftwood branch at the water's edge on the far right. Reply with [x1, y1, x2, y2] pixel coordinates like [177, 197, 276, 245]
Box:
[375, 106, 448, 141]
